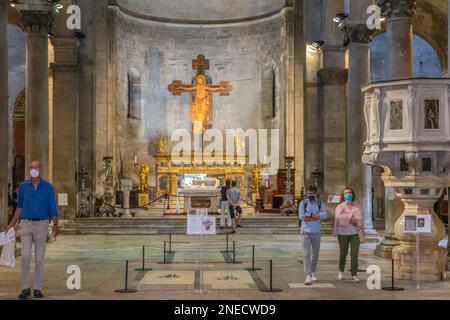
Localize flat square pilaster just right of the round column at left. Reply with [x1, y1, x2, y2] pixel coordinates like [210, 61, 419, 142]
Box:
[51, 37, 78, 218]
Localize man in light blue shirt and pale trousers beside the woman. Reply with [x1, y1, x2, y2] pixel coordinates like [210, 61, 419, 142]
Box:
[299, 185, 328, 285]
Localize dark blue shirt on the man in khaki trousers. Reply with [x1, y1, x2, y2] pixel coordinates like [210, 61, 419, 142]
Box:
[17, 179, 58, 220]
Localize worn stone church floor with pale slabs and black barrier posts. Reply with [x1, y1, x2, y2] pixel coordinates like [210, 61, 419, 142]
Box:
[0, 234, 450, 300]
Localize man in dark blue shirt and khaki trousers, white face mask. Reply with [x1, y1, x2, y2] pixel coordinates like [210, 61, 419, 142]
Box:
[6, 161, 59, 300]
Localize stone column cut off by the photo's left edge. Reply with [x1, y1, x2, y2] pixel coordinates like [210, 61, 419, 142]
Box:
[0, 0, 10, 228]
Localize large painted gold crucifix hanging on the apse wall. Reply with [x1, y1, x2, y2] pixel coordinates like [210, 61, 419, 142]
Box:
[167, 55, 234, 134]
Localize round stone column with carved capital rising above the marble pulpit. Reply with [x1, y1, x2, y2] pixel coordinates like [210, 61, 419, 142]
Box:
[378, 0, 416, 80]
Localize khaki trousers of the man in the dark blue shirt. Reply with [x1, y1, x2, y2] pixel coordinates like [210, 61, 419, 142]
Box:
[19, 220, 49, 290]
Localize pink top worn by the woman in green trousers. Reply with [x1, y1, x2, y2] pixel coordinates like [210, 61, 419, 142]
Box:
[334, 202, 364, 235]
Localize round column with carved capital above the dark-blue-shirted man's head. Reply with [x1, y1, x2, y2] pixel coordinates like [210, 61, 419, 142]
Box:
[18, 1, 53, 174]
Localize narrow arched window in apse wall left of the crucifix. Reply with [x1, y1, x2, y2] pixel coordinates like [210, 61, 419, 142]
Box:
[127, 67, 142, 119]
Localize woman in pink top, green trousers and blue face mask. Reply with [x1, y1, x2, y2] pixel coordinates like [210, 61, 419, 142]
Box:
[334, 188, 364, 283]
